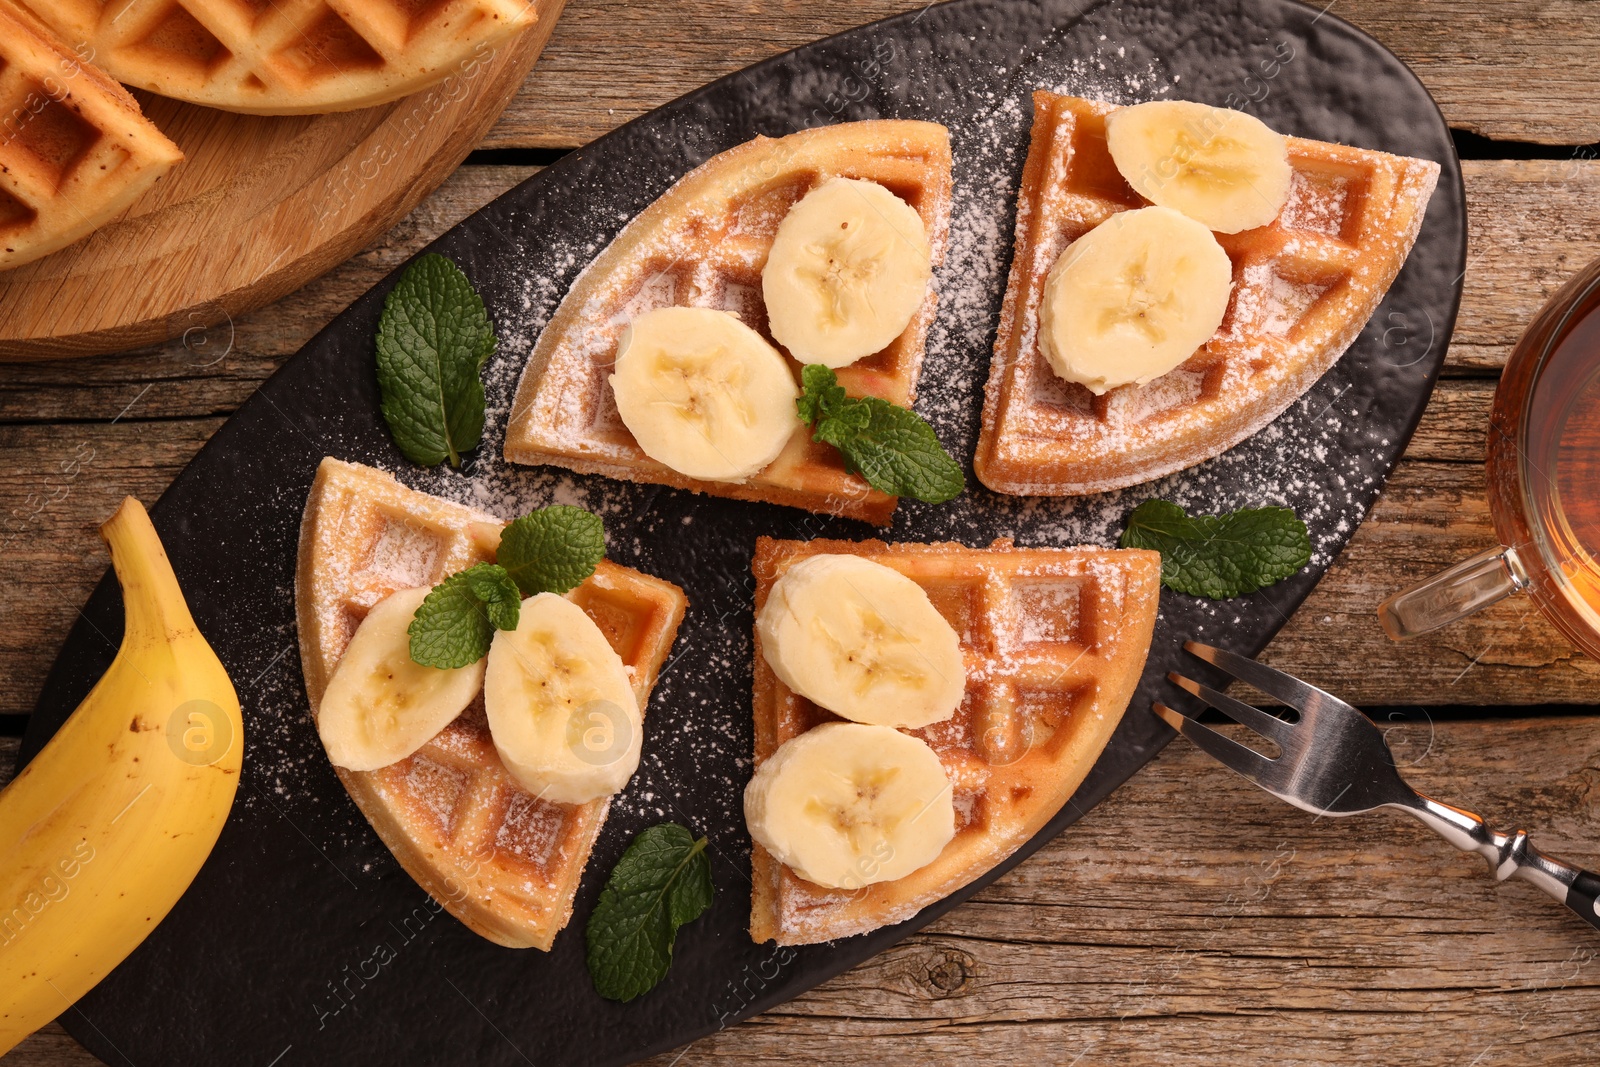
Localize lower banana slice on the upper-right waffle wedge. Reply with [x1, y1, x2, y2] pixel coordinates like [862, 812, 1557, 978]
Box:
[1038, 208, 1234, 395]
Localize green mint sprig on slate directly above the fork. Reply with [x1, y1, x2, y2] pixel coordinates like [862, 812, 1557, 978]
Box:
[1120, 501, 1310, 600]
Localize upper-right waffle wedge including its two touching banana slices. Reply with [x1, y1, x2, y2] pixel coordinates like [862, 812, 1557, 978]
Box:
[973, 91, 1438, 496]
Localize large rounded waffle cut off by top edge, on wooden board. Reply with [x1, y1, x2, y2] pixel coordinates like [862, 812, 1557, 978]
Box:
[26, 0, 538, 115]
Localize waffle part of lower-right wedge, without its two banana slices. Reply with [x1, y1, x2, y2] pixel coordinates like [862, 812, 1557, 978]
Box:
[750, 537, 1162, 945]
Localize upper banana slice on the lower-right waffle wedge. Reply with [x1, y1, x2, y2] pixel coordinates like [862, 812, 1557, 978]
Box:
[755, 555, 966, 729]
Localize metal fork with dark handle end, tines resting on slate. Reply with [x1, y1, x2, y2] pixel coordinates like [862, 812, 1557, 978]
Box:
[1154, 641, 1600, 928]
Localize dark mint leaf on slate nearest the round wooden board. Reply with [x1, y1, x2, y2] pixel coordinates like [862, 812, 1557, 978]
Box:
[378, 253, 494, 467]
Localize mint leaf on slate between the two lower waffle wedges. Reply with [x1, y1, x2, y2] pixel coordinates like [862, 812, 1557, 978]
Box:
[586, 822, 712, 1001]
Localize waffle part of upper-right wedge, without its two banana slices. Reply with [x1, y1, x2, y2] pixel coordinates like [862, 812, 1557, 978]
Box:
[973, 91, 1438, 496]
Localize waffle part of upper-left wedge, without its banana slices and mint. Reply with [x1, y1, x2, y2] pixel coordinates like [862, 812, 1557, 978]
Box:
[506, 120, 950, 525]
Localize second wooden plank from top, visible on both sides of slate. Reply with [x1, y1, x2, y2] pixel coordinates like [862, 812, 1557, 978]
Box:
[0, 160, 1600, 425]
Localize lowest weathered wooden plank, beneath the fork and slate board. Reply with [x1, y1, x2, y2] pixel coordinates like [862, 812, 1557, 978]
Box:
[12, 717, 1600, 1067]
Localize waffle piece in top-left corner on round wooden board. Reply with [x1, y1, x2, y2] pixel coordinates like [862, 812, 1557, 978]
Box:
[0, 0, 184, 270]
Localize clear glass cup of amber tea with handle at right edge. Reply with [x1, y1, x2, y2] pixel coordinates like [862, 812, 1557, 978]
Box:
[1378, 261, 1600, 659]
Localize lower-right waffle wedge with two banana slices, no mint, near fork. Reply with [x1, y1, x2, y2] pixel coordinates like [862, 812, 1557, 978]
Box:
[744, 537, 1162, 945]
